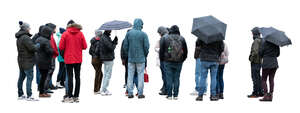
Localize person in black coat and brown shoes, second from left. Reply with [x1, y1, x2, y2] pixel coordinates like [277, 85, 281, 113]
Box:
[36, 26, 53, 97]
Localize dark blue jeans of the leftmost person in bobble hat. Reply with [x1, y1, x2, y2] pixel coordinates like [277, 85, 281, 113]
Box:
[18, 68, 33, 97]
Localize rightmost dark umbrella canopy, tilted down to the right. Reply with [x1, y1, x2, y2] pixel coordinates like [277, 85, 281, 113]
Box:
[259, 27, 292, 47]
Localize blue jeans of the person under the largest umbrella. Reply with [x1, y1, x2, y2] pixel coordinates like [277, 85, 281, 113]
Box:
[198, 61, 219, 96]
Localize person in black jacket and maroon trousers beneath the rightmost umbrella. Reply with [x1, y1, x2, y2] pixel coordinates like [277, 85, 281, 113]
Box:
[260, 41, 280, 101]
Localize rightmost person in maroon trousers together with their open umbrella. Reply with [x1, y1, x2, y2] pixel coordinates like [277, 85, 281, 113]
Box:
[259, 27, 292, 101]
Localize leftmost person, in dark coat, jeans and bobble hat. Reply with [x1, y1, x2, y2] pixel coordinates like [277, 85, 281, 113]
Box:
[15, 21, 39, 101]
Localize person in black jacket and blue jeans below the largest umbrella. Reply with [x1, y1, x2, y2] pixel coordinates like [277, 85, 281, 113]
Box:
[196, 40, 224, 101]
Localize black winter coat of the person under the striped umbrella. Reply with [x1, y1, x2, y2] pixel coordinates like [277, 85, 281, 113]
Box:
[98, 34, 117, 61]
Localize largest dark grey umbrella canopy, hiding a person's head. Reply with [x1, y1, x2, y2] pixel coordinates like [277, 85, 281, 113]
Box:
[192, 16, 227, 44]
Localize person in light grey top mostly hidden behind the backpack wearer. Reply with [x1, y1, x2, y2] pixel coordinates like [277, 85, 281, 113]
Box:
[154, 26, 169, 95]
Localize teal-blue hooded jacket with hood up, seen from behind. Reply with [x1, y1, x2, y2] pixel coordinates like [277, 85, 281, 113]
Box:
[122, 19, 149, 63]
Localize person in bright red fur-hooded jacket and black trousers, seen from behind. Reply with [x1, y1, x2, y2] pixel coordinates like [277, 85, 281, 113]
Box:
[59, 22, 87, 102]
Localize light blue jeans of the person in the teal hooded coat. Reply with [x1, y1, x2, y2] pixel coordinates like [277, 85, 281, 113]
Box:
[127, 63, 145, 95]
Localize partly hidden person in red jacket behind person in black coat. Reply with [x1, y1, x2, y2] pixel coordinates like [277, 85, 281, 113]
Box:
[45, 23, 58, 93]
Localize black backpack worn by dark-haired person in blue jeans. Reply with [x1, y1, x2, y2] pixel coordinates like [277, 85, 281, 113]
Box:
[166, 35, 183, 62]
